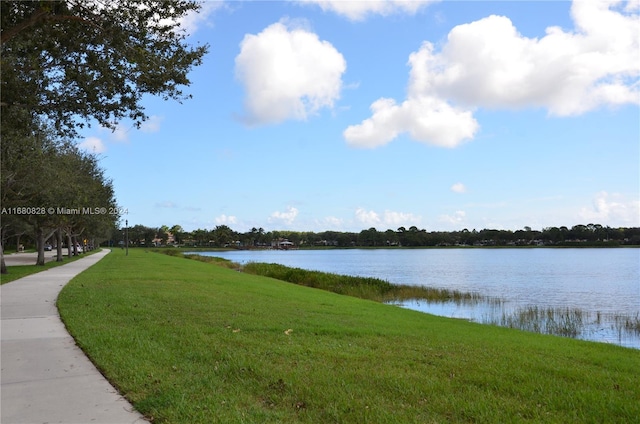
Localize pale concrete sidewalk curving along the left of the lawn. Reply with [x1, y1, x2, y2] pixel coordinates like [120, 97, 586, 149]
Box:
[0, 250, 146, 424]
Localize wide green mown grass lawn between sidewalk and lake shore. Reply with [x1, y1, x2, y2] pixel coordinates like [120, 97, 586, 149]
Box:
[58, 249, 640, 424]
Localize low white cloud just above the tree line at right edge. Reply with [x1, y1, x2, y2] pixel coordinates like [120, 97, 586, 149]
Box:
[580, 191, 640, 227]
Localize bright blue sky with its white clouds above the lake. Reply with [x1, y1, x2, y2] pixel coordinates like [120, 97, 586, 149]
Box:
[81, 1, 640, 232]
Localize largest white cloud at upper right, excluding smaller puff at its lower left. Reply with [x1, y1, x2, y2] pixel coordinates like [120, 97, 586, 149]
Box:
[410, 1, 640, 116]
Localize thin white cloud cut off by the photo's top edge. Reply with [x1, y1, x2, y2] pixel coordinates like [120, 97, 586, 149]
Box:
[298, 0, 437, 21]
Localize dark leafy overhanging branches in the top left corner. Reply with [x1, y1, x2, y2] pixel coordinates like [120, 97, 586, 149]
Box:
[0, 0, 207, 135]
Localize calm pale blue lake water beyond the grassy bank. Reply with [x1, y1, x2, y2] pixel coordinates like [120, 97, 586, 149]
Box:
[192, 248, 640, 348]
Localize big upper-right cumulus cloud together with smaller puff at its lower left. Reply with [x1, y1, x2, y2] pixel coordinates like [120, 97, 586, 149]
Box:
[343, 0, 640, 147]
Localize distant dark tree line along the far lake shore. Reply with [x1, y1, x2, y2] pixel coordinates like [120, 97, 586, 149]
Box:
[102, 224, 640, 249]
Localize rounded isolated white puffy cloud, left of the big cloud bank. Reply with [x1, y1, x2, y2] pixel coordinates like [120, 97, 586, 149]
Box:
[236, 22, 347, 124]
